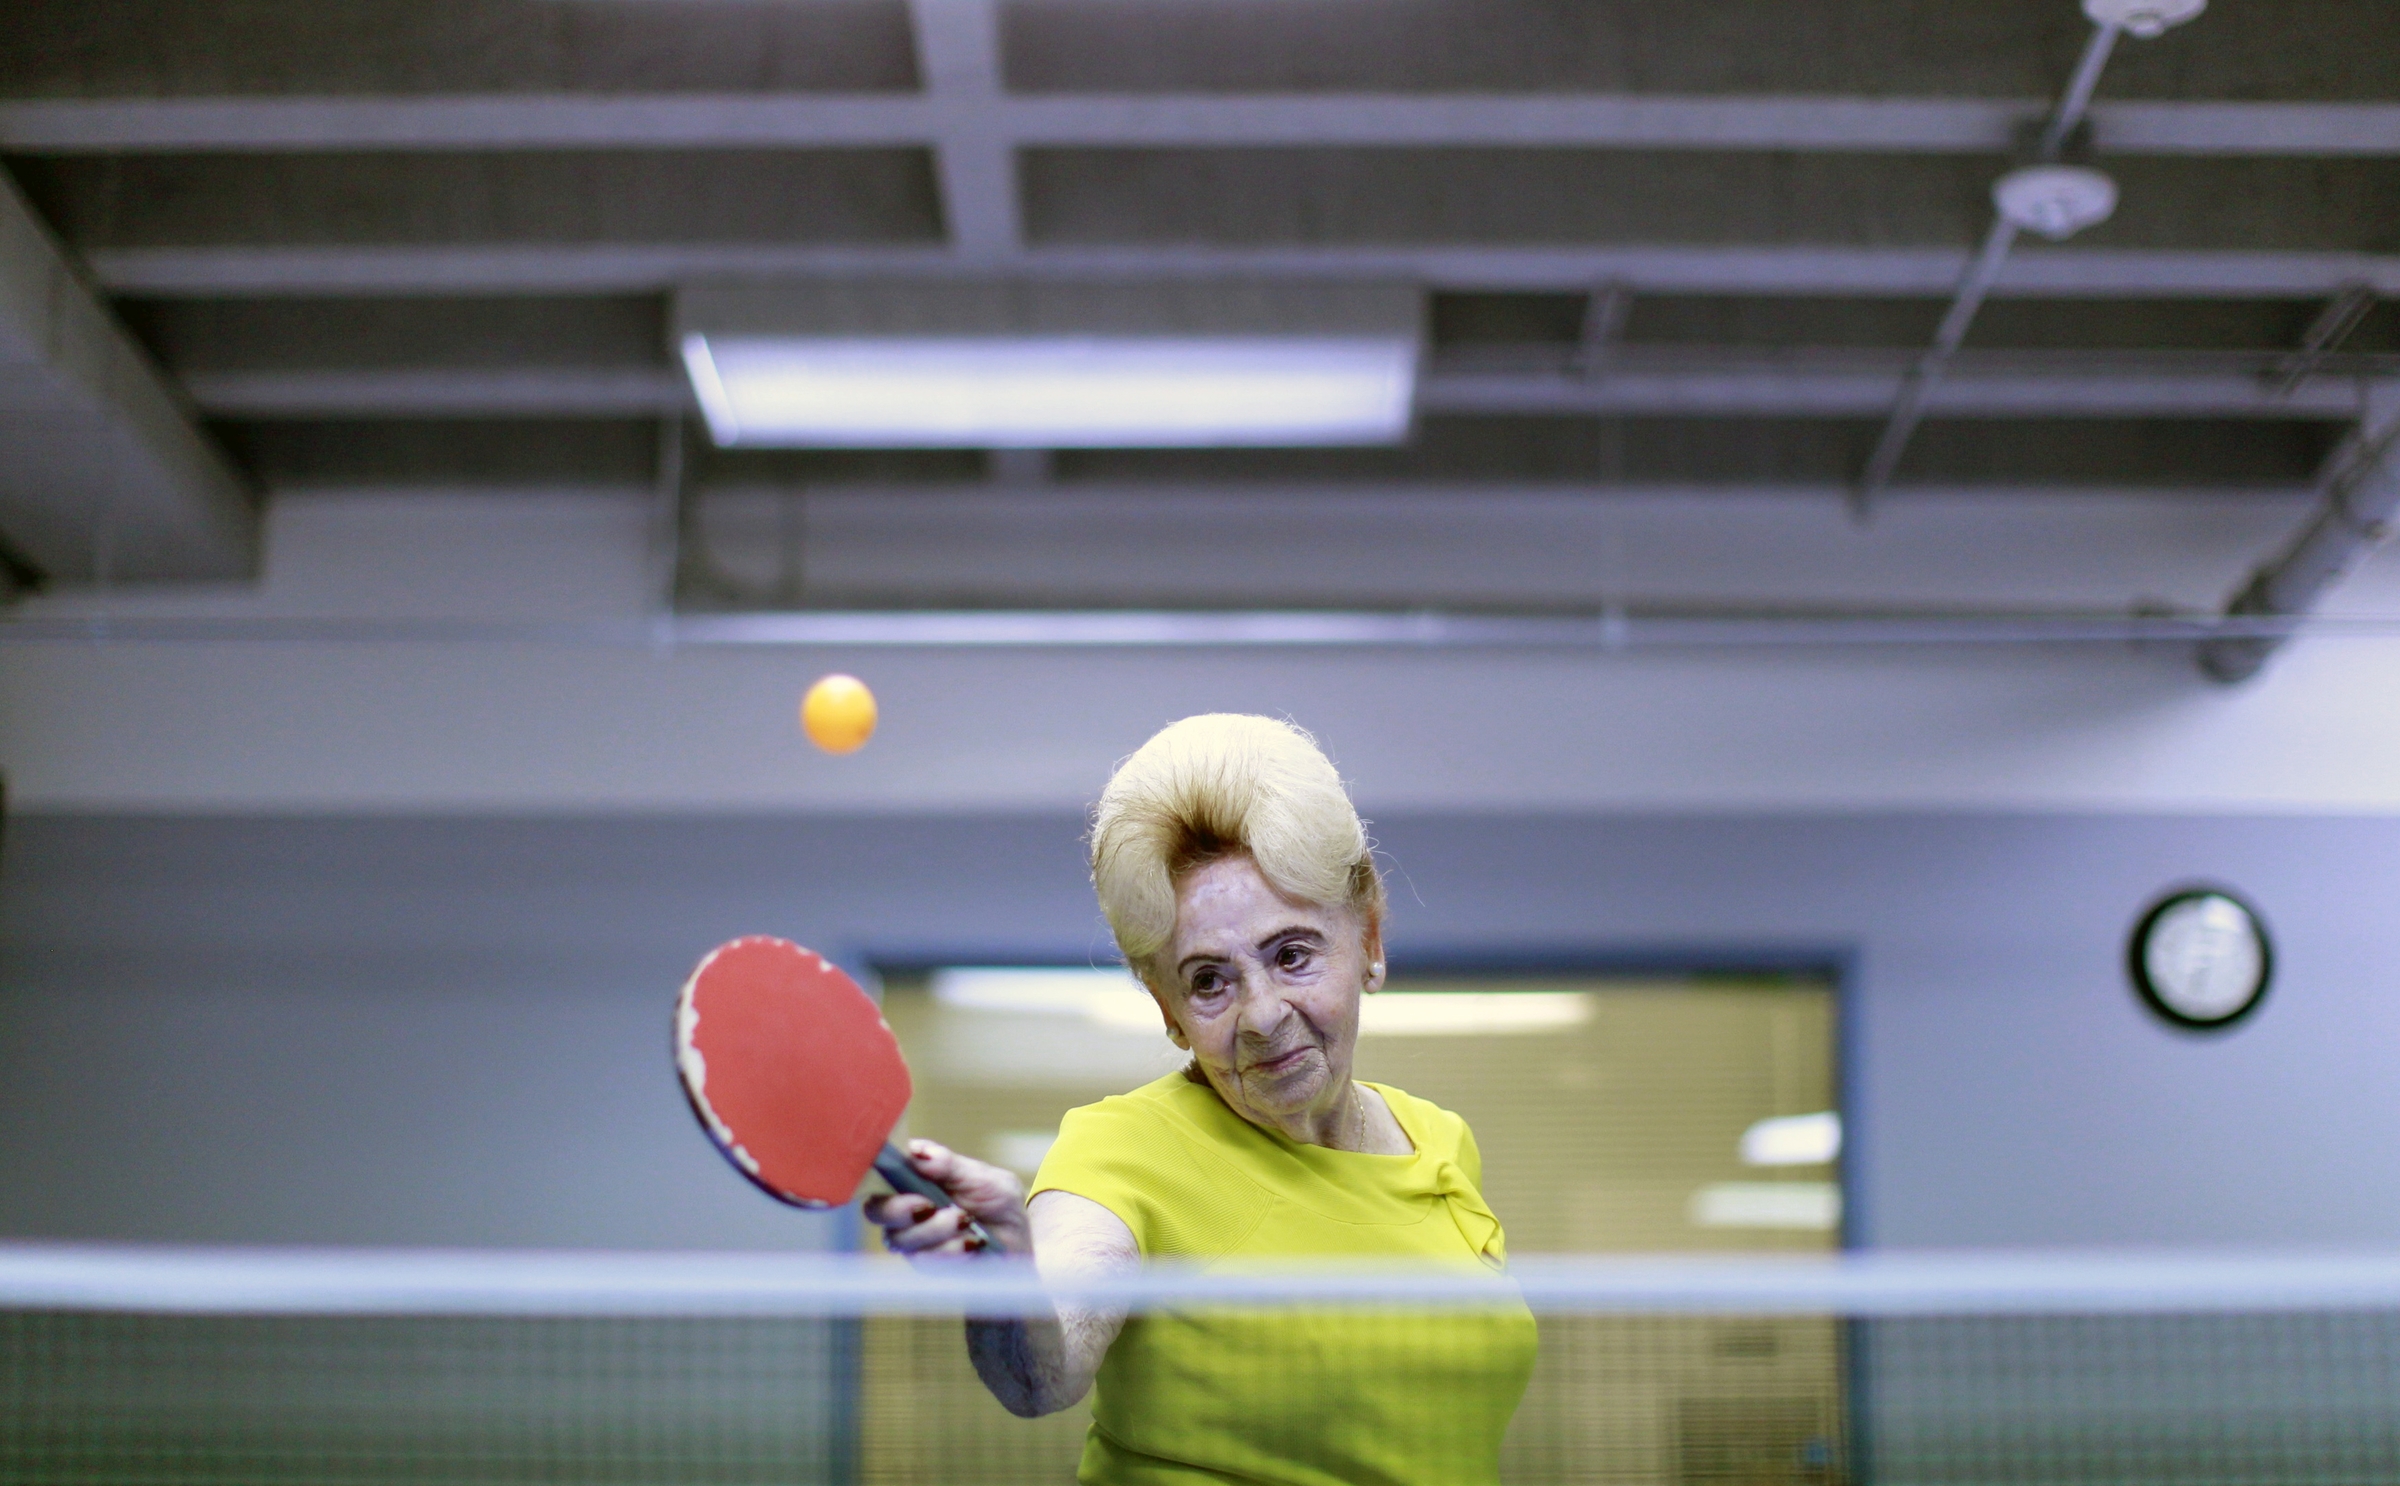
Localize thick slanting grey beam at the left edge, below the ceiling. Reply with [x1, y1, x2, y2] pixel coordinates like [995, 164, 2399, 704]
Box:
[0, 175, 259, 576]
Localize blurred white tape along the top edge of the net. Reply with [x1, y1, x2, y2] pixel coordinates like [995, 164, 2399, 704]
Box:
[0, 1244, 2400, 1318]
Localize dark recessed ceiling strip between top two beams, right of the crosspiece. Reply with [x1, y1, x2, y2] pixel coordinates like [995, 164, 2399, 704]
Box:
[1022, 146, 2400, 259]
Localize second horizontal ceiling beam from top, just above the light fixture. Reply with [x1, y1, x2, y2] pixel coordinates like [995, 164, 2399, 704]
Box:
[86, 242, 2400, 298]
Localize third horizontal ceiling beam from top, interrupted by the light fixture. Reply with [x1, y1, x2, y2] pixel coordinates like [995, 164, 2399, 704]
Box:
[185, 350, 2359, 423]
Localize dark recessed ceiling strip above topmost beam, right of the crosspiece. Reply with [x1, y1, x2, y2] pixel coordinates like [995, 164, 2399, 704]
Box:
[1006, 0, 2400, 101]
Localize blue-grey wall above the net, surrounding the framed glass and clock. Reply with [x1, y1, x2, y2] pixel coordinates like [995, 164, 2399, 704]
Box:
[0, 814, 2400, 1246]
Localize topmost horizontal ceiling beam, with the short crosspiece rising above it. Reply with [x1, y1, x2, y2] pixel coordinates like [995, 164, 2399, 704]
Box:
[0, 96, 2400, 156]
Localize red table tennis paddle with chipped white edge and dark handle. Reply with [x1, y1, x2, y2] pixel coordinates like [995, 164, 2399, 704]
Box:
[674, 934, 991, 1246]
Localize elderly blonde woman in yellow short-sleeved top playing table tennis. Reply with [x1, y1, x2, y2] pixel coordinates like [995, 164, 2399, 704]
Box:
[866, 715, 1534, 1486]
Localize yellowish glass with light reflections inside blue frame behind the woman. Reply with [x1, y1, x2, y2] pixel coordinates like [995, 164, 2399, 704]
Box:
[859, 967, 1846, 1486]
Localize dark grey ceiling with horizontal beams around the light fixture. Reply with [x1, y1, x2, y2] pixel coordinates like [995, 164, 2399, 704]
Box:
[0, 0, 2400, 607]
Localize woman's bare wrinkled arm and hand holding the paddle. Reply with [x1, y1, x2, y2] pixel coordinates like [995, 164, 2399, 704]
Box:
[866, 1140, 1142, 1419]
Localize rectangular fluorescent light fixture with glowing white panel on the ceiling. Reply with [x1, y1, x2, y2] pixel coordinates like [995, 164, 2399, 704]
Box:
[677, 283, 1421, 449]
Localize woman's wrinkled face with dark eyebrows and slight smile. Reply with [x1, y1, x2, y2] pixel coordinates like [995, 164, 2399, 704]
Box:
[1152, 855, 1382, 1138]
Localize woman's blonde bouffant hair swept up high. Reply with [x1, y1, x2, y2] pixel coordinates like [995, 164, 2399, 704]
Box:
[1092, 713, 1385, 979]
